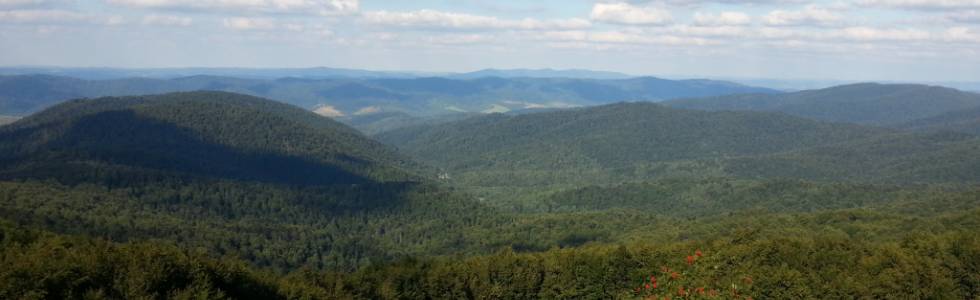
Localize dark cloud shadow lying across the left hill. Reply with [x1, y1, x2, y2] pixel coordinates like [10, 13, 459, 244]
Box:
[0, 110, 376, 186]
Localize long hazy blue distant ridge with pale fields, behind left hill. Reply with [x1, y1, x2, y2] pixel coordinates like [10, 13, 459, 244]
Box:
[0, 75, 777, 116]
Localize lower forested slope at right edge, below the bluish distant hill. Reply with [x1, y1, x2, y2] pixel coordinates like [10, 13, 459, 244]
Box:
[725, 132, 980, 183]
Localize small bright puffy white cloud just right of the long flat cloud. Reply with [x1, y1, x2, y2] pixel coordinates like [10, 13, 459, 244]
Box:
[590, 3, 673, 26]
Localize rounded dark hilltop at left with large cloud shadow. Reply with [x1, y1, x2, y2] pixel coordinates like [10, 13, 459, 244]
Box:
[0, 92, 416, 185]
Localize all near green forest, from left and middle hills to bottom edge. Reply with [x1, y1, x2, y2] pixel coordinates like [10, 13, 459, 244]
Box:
[0, 92, 980, 299]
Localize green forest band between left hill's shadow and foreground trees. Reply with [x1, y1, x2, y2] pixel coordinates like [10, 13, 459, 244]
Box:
[0, 181, 492, 270]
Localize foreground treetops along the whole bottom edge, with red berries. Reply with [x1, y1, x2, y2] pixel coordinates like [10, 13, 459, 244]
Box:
[0, 210, 980, 299]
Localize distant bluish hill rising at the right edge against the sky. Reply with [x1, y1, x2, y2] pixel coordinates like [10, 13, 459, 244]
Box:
[665, 83, 980, 126]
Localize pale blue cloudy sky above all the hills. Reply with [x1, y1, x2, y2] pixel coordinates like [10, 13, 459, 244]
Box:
[0, 0, 980, 81]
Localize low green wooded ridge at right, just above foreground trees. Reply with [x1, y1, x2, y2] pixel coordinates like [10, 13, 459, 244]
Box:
[537, 179, 980, 218]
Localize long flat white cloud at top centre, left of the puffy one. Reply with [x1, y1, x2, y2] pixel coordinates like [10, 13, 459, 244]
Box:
[363, 9, 592, 30]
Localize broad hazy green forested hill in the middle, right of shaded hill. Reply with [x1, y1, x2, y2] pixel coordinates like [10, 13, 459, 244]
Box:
[375, 103, 889, 184]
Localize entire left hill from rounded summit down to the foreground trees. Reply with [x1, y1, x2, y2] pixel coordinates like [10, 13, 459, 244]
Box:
[0, 92, 506, 270]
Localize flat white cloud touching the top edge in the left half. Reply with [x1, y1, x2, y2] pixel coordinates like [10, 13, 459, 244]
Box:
[106, 0, 360, 15]
